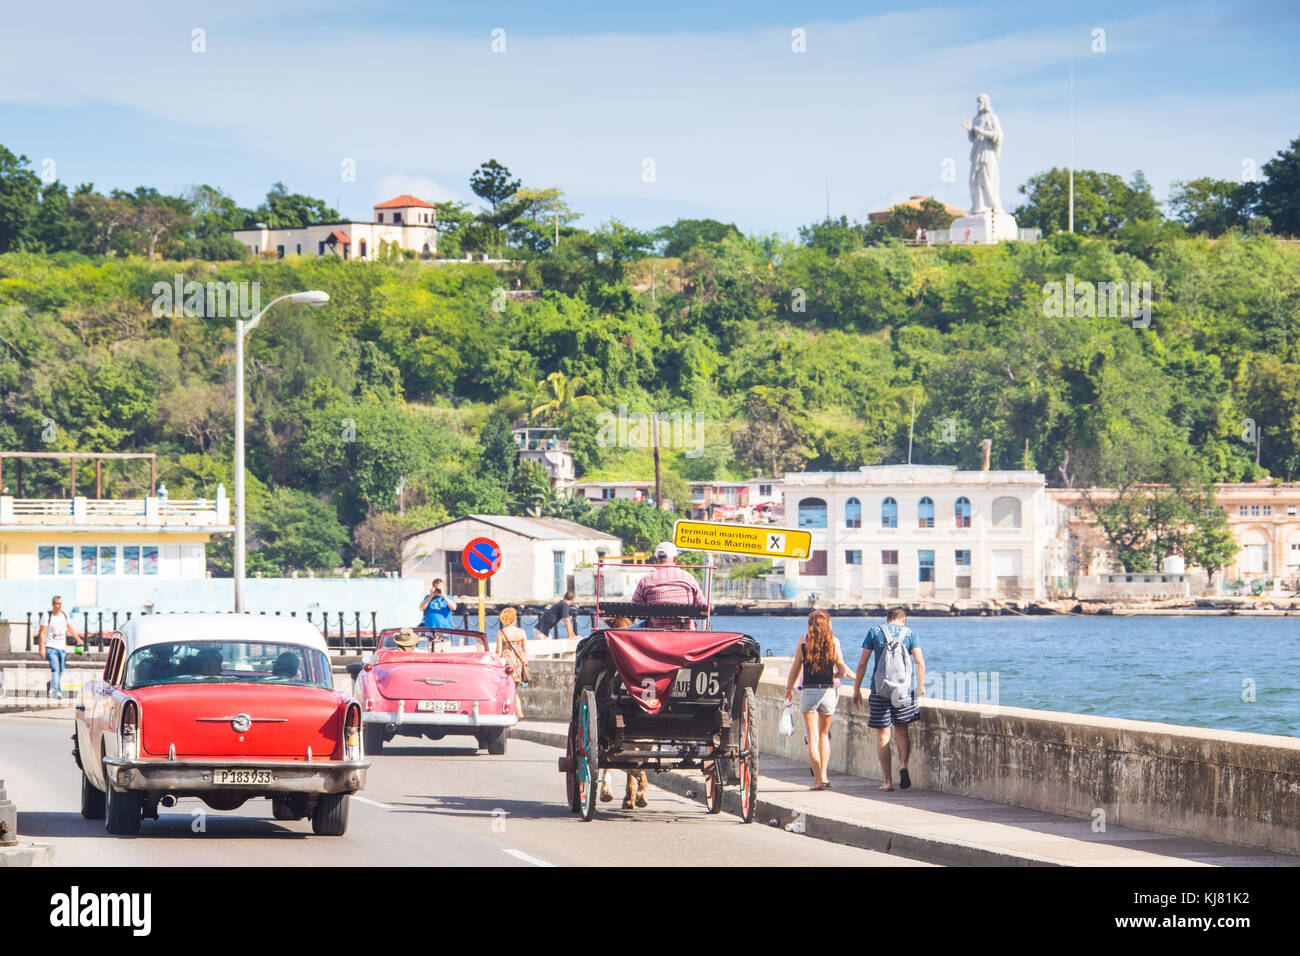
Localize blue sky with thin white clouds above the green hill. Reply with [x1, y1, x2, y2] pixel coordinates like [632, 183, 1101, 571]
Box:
[0, 0, 1300, 234]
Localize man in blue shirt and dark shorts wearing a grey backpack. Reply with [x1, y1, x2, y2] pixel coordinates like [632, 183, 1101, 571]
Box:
[853, 607, 926, 791]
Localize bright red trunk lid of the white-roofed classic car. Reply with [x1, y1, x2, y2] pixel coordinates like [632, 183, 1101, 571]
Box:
[133, 684, 342, 760]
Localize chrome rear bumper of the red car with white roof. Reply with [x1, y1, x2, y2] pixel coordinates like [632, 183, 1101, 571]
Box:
[104, 757, 371, 793]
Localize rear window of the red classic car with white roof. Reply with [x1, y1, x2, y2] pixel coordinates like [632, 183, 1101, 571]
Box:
[122, 641, 334, 689]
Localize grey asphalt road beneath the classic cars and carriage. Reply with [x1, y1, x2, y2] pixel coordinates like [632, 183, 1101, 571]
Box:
[0, 710, 919, 866]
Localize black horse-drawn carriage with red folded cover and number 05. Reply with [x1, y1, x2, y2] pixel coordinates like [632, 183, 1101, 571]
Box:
[560, 562, 763, 823]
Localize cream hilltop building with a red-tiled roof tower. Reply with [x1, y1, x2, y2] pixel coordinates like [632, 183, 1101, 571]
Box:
[233, 195, 438, 260]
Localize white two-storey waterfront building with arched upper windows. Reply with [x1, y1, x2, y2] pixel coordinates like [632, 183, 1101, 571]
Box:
[777, 464, 1067, 601]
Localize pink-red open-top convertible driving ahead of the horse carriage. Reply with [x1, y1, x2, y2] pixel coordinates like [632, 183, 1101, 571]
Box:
[348, 627, 519, 753]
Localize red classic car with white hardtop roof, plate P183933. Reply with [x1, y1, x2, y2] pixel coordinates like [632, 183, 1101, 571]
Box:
[73, 614, 369, 836]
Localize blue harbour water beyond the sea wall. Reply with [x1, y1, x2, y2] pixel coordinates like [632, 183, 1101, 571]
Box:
[712, 617, 1300, 736]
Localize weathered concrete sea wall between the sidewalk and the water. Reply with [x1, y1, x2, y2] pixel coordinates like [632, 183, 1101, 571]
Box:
[514, 659, 1300, 855]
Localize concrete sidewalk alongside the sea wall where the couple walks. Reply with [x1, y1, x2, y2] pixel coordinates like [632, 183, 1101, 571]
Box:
[511, 719, 1300, 866]
